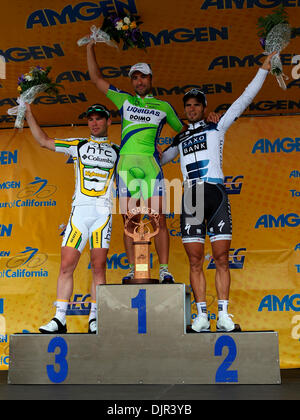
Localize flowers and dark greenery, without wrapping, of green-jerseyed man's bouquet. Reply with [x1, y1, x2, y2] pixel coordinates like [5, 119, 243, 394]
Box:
[101, 14, 146, 49]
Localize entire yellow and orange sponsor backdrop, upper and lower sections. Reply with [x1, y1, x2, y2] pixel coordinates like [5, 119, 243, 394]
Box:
[0, 0, 300, 369]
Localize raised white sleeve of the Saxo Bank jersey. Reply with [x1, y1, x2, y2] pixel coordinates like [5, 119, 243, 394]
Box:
[217, 68, 268, 131]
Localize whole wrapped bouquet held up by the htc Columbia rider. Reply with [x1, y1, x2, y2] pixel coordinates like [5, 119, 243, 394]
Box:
[7, 66, 62, 128]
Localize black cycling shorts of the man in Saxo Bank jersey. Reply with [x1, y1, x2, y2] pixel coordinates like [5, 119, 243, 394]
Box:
[180, 181, 232, 244]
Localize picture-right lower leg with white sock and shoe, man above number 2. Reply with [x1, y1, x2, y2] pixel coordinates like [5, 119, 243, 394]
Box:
[211, 240, 235, 331]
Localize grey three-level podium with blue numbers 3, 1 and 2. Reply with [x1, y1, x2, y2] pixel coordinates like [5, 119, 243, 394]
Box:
[8, 284, 281, 384]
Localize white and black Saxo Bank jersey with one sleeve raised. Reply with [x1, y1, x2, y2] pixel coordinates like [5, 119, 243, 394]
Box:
[161, 68, 268, 184]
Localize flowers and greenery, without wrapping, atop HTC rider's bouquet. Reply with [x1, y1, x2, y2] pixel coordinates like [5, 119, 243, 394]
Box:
[18, 66, 62, 96]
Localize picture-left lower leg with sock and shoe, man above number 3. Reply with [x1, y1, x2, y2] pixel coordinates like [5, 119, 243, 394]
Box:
[39, 246, 81, 334]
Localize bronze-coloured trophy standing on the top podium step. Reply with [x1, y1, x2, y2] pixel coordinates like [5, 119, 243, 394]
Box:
[123, 207, 159, 284]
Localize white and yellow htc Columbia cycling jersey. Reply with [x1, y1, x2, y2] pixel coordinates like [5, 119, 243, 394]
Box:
[55, 136, 119, 209]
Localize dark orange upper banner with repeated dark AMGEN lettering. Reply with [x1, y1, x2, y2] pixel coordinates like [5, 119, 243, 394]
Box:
[0, 0, 300, 128]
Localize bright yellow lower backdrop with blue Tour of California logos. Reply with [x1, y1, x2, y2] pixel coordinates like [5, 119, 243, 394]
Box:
[0, 116, 300, 369]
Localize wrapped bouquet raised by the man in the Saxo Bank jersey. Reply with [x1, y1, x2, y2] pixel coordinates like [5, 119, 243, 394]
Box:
[257, 7, 292, 90]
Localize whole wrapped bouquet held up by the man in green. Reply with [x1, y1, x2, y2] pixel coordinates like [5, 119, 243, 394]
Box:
[77, 14, 146, 50]
